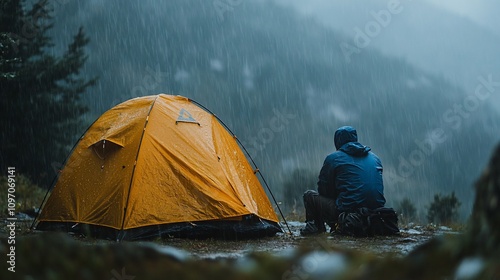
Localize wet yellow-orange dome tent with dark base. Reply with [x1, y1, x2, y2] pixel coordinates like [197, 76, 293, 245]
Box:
[36, 94, 281, 240]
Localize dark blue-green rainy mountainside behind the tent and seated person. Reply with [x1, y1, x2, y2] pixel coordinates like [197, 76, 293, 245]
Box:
[47, 0, 498, 217]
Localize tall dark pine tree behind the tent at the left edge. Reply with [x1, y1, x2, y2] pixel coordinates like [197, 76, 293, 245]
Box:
[0, 0, 96, 186]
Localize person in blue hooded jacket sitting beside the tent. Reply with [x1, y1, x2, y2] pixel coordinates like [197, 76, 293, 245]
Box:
[300, 126, 385, 235]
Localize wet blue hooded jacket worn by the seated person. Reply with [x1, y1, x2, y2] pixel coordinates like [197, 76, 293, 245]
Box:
[318, 126, 385, 212]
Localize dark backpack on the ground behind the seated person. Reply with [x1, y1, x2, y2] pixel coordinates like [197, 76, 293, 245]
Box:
[337, 207, 399, 237]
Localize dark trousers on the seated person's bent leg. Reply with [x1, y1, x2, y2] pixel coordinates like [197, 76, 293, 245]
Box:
[303, 190, 339, 232]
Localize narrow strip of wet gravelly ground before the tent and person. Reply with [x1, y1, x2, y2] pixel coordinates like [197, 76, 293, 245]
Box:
[137, 221, 459, 259]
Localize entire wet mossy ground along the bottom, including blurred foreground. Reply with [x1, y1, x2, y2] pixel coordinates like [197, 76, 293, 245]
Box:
[0, 220, 476, 280]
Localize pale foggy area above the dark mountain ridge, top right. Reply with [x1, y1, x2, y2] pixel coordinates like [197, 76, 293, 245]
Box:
[276, 0, 500, 108]
